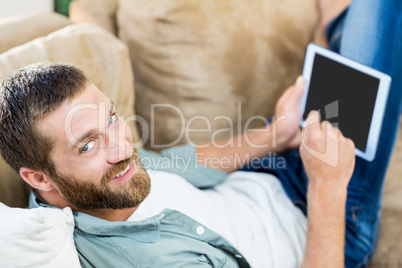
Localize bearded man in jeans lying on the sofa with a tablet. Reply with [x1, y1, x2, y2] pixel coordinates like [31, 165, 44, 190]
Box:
[0, 1, 401, 267]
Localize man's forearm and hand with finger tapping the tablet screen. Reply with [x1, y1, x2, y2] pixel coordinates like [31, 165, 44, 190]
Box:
[300, 112, 355, 267]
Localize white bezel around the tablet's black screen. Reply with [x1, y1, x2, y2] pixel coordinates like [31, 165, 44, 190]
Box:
[300, 44, 391, 162]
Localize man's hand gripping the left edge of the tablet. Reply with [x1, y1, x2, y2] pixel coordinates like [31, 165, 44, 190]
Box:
[274, 76, 305, 152]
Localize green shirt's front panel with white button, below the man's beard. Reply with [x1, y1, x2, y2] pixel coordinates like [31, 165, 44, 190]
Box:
[74, 209, 249, 268]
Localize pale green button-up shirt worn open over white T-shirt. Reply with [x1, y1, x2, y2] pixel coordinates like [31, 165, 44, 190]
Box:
[31, 145, 250, 268]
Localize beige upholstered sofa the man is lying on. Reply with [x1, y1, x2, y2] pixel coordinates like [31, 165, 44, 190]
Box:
[0, 0, 402, 267]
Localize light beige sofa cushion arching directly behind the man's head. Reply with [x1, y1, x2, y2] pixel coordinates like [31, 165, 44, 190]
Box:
[0, 24, 138, 206]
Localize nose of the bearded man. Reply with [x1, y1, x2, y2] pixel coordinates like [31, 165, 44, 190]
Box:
[106, 126, 134, 164]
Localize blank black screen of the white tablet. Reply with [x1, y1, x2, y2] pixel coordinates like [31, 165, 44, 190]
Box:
[303, 54, 380, 152]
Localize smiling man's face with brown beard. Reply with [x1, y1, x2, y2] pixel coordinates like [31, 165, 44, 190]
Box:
[38, 85, 150, 210]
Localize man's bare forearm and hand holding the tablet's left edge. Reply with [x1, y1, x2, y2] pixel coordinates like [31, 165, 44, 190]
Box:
[196, 77, 305, 173]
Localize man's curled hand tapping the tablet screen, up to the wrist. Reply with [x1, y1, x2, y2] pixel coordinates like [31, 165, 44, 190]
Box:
[300, 111, 355, 189]
